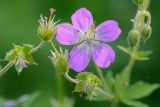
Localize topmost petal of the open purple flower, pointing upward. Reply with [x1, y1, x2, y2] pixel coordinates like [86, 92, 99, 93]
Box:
[72, 8, 93, 32]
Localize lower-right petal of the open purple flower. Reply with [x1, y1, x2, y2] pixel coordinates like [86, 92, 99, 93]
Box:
[92, 43, 115, 68]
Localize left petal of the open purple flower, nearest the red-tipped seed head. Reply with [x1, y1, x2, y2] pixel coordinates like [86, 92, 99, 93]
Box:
[56, 24, 80, 45]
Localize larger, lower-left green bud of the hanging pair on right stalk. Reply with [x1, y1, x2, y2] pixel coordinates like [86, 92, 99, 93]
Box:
[127, 29, 140, 47]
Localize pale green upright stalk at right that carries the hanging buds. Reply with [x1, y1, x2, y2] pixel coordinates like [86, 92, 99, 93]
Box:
[125, 0, 151, 85]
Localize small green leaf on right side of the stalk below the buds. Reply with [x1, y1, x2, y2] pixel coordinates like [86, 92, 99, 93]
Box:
[134, 51, 152, 61]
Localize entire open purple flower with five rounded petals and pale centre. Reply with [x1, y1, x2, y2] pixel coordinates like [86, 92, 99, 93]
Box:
[56, 8, 121, 72]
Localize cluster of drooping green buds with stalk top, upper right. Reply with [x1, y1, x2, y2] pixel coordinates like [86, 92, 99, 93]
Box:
[127, 0, 152, 48]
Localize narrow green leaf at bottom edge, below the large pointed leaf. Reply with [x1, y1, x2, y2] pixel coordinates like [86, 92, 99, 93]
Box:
[121, 98, 149, 107]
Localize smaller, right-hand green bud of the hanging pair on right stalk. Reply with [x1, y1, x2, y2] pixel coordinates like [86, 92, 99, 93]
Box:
[141, 24, 152, 40]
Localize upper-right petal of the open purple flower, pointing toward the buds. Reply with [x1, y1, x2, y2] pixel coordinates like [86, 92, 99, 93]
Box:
[95, 20, 121, 42]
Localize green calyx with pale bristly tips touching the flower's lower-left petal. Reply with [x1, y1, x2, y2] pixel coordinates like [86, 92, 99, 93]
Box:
[51, 48, 69, 73]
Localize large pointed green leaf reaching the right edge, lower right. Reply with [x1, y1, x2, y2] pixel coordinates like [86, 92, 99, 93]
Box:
[123, 81, 160, 99]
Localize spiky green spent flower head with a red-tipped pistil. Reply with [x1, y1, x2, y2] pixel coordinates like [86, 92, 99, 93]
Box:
[38, 8, 58, 41]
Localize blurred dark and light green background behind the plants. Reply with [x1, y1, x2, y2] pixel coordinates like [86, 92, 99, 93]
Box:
[0, 0, 160, 107]
